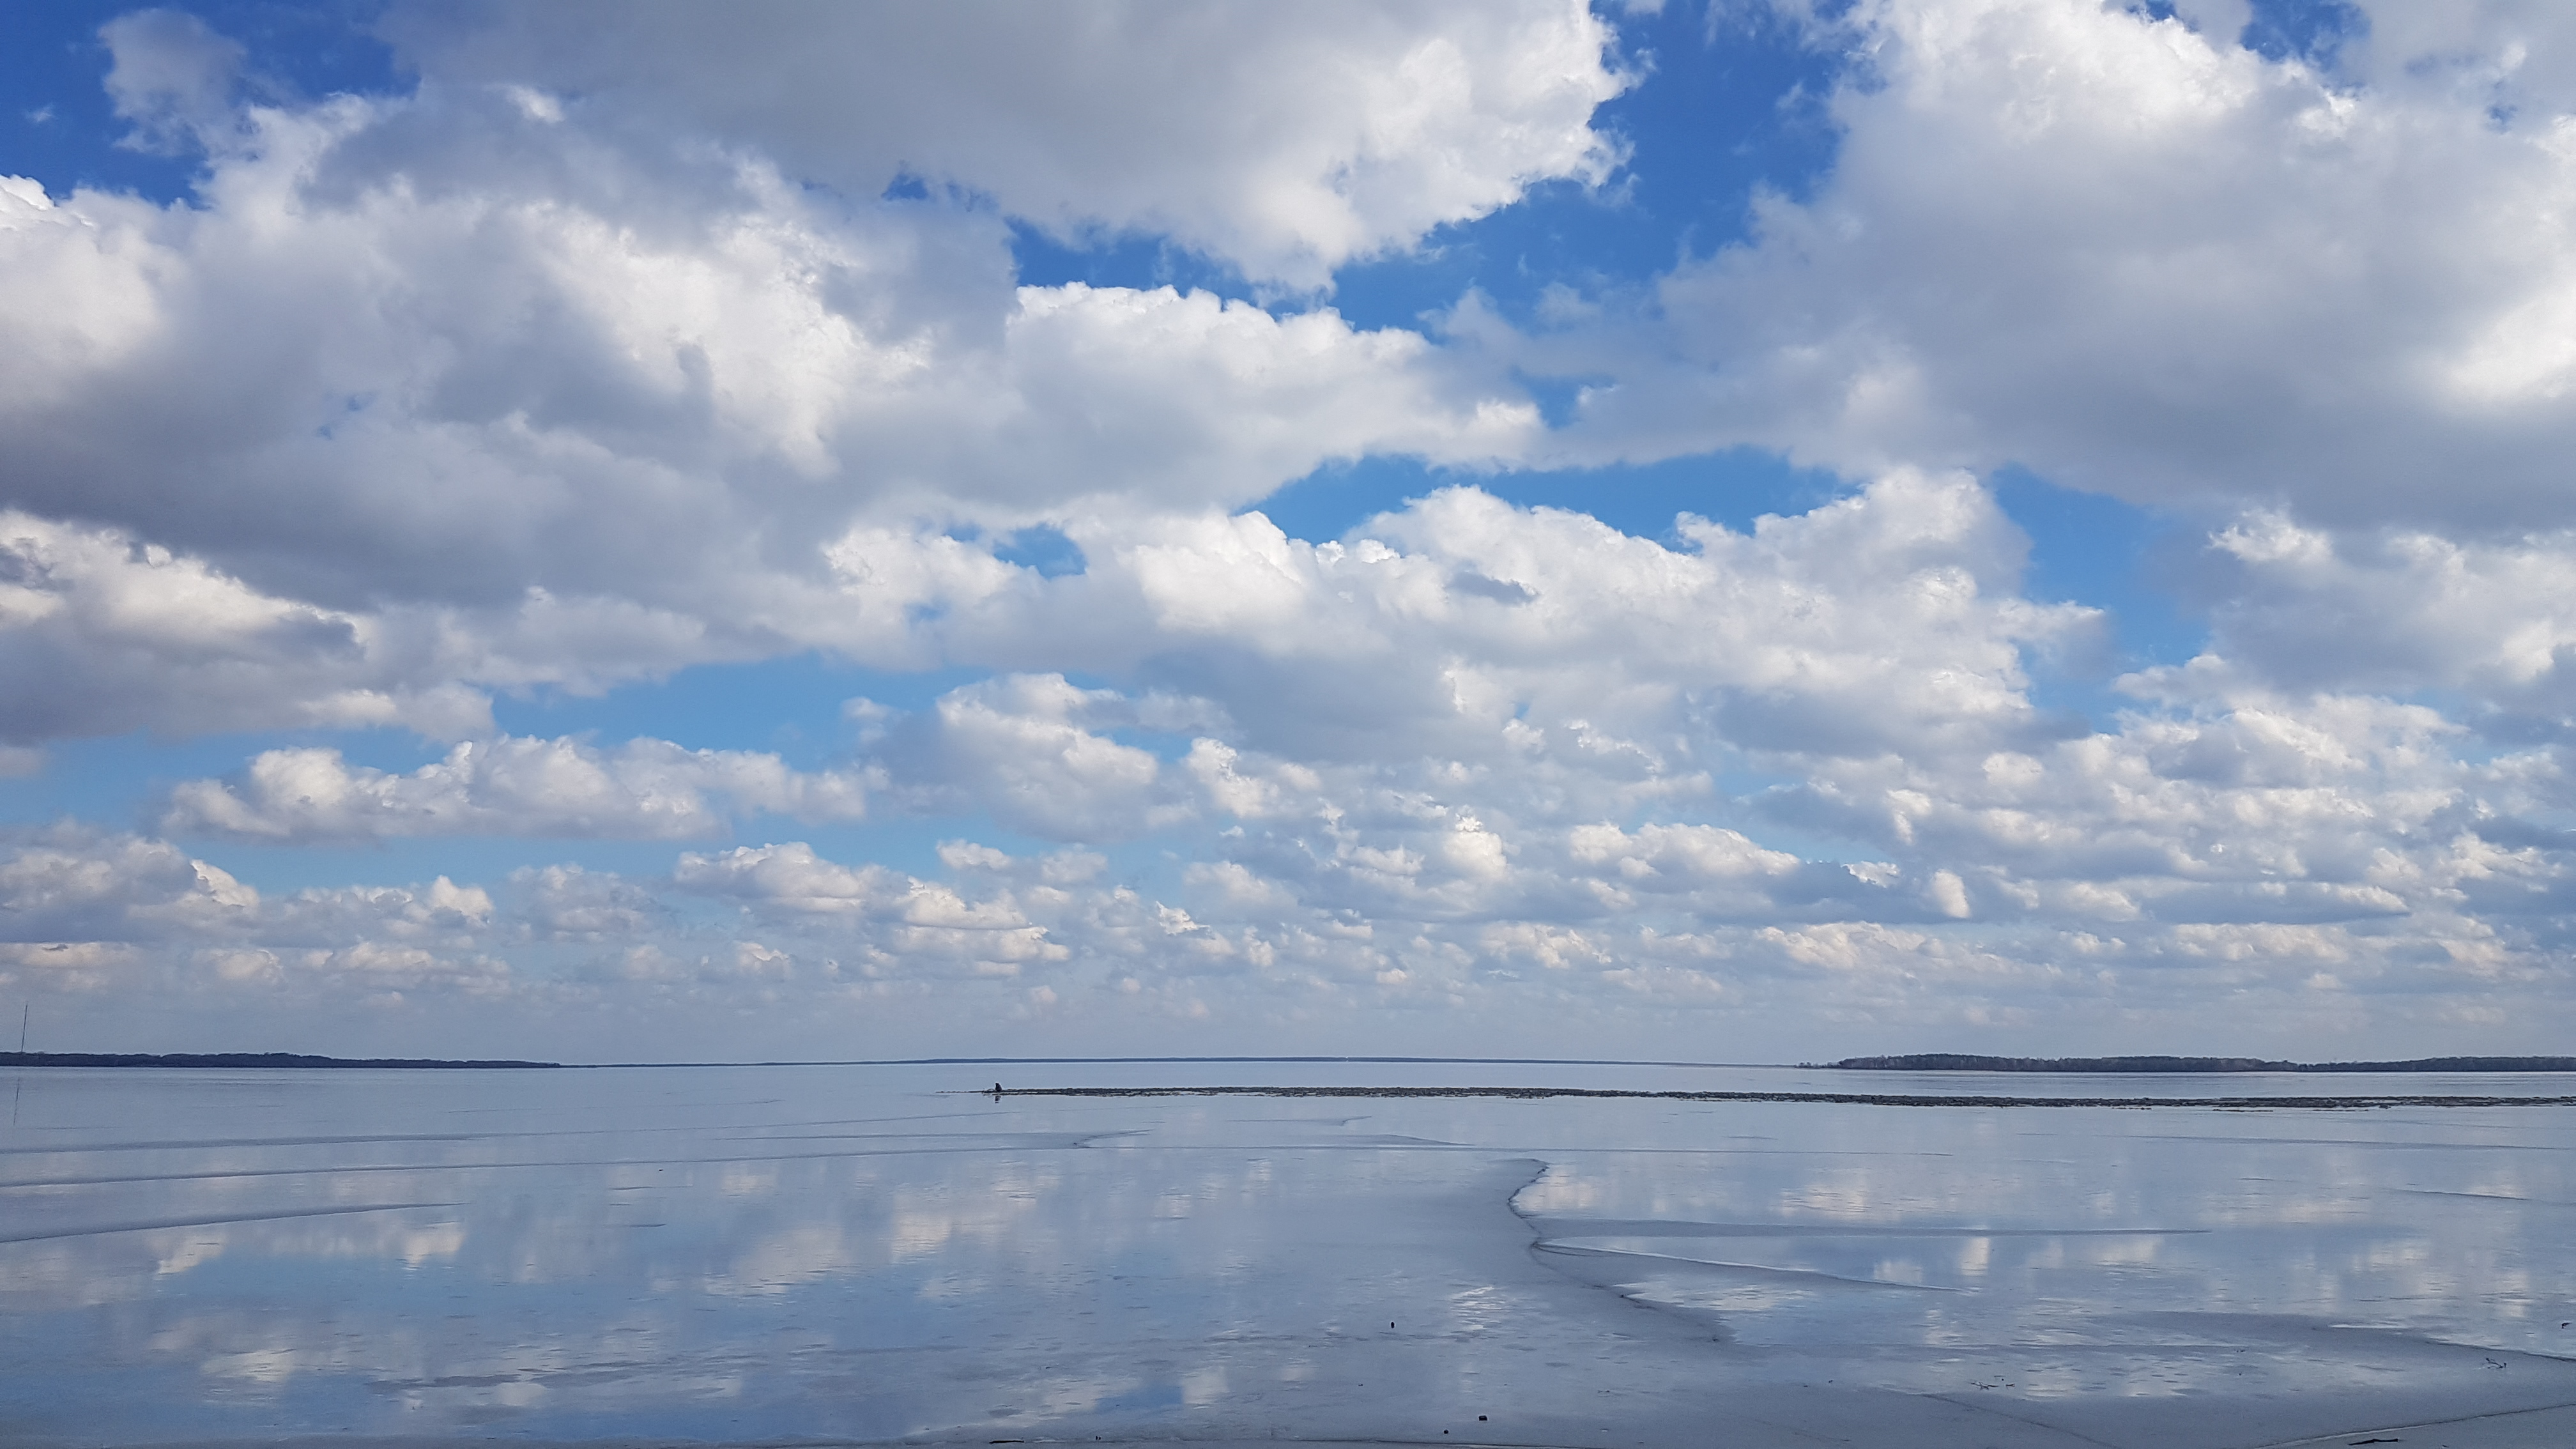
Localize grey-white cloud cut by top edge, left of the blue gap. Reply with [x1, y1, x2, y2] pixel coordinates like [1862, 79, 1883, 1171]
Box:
[389, 0, 1628, 286]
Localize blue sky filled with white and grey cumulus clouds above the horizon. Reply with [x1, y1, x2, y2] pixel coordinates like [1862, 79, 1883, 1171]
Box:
[0, 0, 2576, 1062]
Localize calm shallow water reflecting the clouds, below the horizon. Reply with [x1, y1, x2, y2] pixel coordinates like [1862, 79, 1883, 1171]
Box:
[0, 1062, 2576, 1446]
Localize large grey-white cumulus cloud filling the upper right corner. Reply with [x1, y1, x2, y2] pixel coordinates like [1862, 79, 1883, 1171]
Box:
[1525, 0, 2576, 528]
